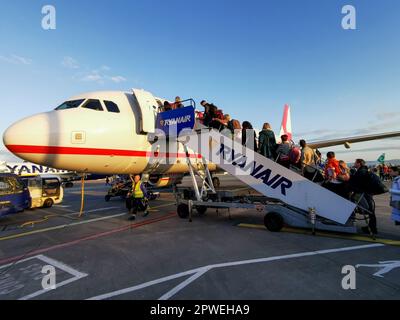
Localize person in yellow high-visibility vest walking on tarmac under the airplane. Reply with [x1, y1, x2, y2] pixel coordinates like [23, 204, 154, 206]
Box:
[127, 175, 149, 220]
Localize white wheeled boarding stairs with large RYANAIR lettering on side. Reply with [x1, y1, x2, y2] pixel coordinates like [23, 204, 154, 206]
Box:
[152, 104, 372, 234]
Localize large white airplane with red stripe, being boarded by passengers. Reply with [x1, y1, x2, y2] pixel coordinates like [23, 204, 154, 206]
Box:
[3, 89, 400, 187]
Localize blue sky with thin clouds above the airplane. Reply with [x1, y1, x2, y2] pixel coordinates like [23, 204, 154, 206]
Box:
[0, 0, 400, 161]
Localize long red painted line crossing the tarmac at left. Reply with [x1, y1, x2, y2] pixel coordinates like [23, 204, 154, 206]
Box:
[0, 212, 176, 265]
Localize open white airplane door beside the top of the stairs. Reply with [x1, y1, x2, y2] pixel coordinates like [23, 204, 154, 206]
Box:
[132, 89, 158, 134]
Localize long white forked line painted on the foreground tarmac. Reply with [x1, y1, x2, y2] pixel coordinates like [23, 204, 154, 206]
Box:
[87, 243, 385, 300]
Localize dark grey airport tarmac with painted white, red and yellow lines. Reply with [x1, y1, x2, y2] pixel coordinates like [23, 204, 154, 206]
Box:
[0, 175, 400, 300]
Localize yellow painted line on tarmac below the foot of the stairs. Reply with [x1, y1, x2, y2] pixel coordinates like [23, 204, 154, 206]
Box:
[237, 223, 400, 246]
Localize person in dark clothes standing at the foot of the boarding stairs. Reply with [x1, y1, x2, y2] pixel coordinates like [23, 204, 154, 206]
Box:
[349, 159, 378, 234]
